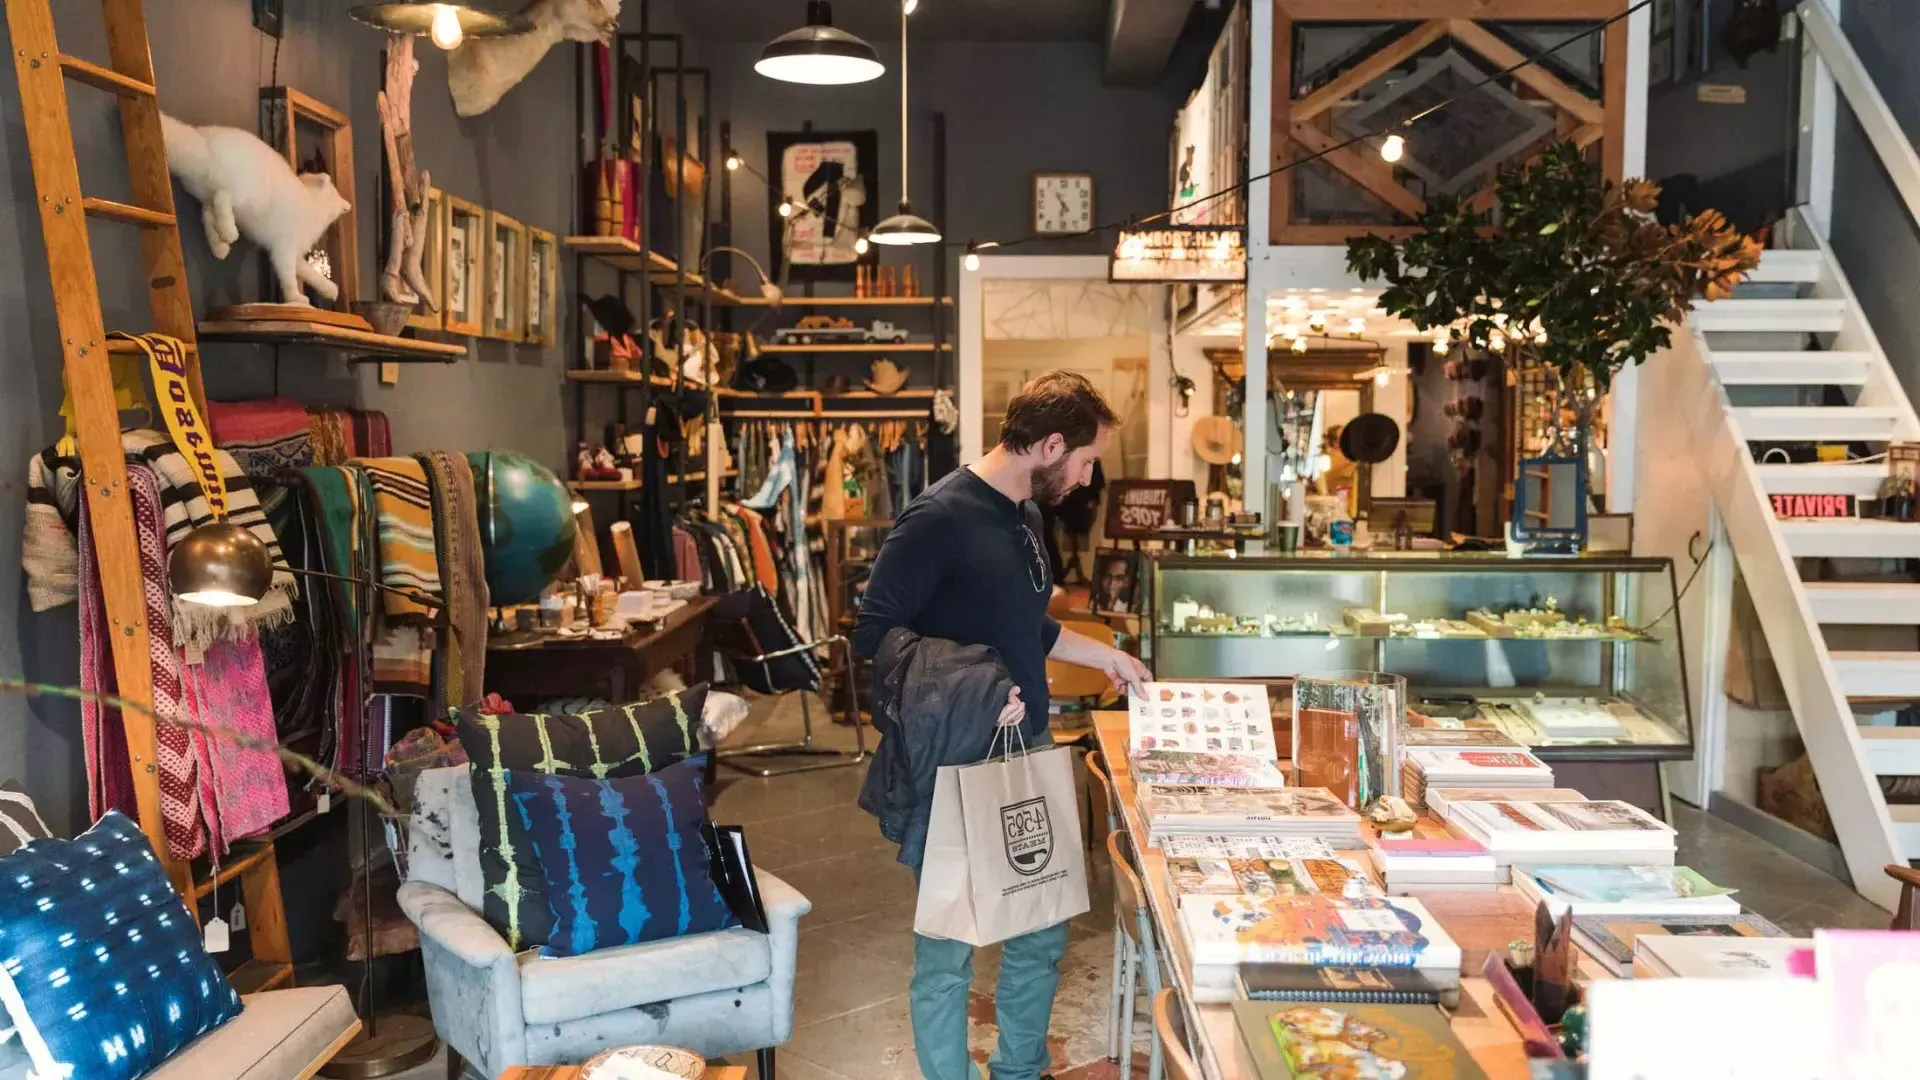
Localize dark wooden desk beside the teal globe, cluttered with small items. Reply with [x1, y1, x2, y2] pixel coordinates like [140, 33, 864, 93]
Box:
[486, 596, 714, 709]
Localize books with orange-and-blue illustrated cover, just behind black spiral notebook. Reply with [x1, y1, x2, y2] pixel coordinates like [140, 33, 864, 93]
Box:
[1181, 894, 1461, 1003]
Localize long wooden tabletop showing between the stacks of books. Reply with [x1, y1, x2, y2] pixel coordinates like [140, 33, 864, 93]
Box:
[1094, 711, 1596, 1080]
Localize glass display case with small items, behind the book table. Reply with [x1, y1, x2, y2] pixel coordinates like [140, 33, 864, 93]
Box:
[1146, 552, 1693, 761]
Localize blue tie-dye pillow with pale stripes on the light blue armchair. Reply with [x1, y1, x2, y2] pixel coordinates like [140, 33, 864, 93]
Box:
[507, 755, 739, 957]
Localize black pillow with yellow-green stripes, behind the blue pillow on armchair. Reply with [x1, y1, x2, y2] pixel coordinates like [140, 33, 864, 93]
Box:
[455, 682, 707, 949]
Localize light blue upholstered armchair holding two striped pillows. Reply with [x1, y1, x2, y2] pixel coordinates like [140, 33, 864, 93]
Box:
[399, 767, 812, 1076]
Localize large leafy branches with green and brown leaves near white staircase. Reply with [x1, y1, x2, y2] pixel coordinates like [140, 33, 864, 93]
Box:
[1346, 142, 1761, 457]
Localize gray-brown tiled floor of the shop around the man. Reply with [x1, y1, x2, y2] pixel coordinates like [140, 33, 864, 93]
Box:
[407, 687, 1887, 1080]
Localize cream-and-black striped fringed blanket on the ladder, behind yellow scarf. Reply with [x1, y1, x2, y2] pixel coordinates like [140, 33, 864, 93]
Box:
[121, 429, 300, 641]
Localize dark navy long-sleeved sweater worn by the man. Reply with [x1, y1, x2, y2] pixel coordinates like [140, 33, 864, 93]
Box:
[852, 469, 1060, 744]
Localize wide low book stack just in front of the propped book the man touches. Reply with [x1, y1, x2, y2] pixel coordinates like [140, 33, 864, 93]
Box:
[1139, 784, 1359, 847]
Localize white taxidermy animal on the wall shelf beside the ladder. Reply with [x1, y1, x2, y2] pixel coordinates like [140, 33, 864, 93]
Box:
[159, 113, 353, 304]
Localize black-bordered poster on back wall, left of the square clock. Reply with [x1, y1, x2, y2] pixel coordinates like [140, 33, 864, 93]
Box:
[766, 131, 893, 282]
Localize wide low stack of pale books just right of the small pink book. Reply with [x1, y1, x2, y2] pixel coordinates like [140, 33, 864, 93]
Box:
[1446, 799, 1674, 867]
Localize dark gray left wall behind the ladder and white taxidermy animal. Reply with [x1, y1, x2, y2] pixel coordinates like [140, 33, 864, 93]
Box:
[0, 0, 706, 830]
